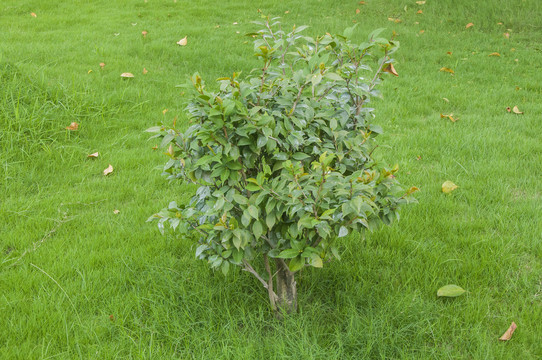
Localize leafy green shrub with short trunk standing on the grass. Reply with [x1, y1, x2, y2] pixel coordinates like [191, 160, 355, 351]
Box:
[148, 17, 416, 312]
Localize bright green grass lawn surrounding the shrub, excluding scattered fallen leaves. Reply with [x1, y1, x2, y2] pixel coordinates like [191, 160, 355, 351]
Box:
[0, 0, 542, 359]
